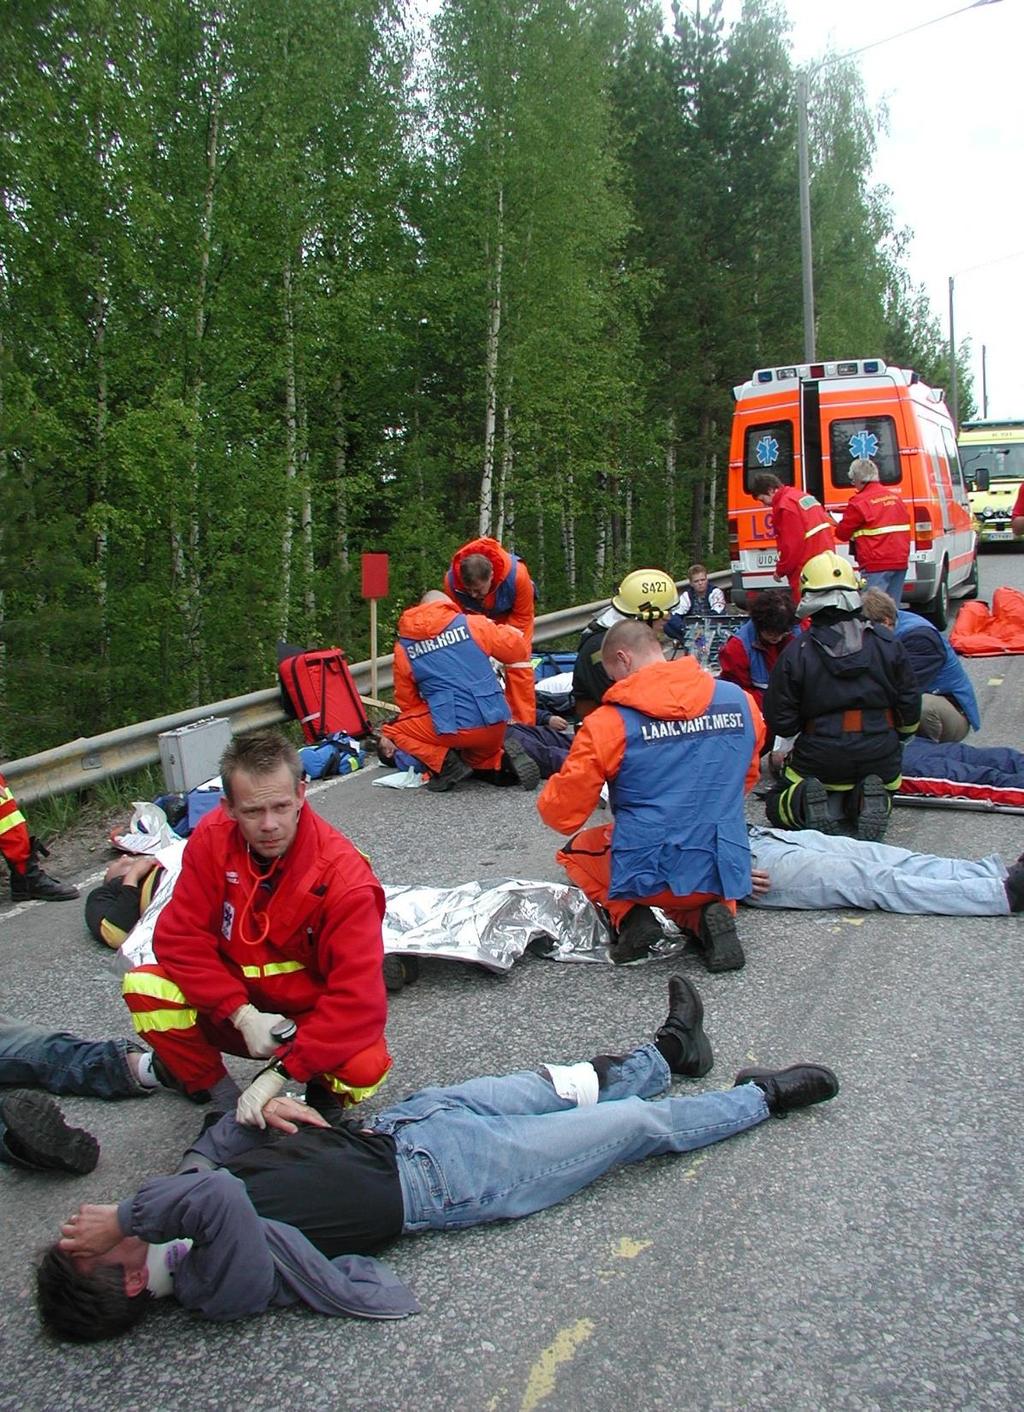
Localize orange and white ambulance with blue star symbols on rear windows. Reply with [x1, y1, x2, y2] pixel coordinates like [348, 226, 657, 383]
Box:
[729, 357, 977, 627]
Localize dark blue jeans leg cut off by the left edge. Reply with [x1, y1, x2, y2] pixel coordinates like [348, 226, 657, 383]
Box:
[0, 1015, 148, 1162]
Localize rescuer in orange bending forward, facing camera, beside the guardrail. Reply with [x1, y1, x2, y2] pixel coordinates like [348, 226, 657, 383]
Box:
[443, 538, 537, 726]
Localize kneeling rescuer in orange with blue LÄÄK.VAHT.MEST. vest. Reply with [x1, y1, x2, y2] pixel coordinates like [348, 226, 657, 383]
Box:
[537, 621, 764, 971]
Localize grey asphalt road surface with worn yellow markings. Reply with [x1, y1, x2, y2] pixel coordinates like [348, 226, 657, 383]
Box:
[0, 551, 1024, 1412]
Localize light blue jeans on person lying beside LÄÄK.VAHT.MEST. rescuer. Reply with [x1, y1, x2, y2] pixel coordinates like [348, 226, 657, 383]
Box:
[744, 827, 1010, 916]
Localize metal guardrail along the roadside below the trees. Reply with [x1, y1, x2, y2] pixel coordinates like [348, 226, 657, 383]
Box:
[0, 572, 730, 803]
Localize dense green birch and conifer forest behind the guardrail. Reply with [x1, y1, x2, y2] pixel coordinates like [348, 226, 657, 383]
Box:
[0, 0, 970, 755]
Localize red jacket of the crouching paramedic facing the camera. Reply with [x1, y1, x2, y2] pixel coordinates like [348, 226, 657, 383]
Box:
[153, 803, 387, 1082]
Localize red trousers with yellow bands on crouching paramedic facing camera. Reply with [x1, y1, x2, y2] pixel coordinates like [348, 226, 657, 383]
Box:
[123, 966, 391, 1104]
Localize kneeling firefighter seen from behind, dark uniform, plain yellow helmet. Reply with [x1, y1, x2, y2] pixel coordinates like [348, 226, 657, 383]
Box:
[764, 551, 921, 842]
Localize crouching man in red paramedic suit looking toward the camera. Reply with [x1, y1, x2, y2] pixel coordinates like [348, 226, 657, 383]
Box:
[124, 731, 391, 1127]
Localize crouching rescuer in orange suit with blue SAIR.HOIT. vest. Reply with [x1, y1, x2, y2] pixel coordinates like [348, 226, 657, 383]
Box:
[380, 589, 530, 792]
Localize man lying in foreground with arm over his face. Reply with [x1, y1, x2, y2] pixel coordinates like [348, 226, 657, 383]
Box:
[37, 976, 839, 1341]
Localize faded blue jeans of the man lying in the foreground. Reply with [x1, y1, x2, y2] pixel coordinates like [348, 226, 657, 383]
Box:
[371, 1045, 768, 1231]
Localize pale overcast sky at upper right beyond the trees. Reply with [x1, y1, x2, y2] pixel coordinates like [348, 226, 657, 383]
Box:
[723, 0, 1024, 418]
